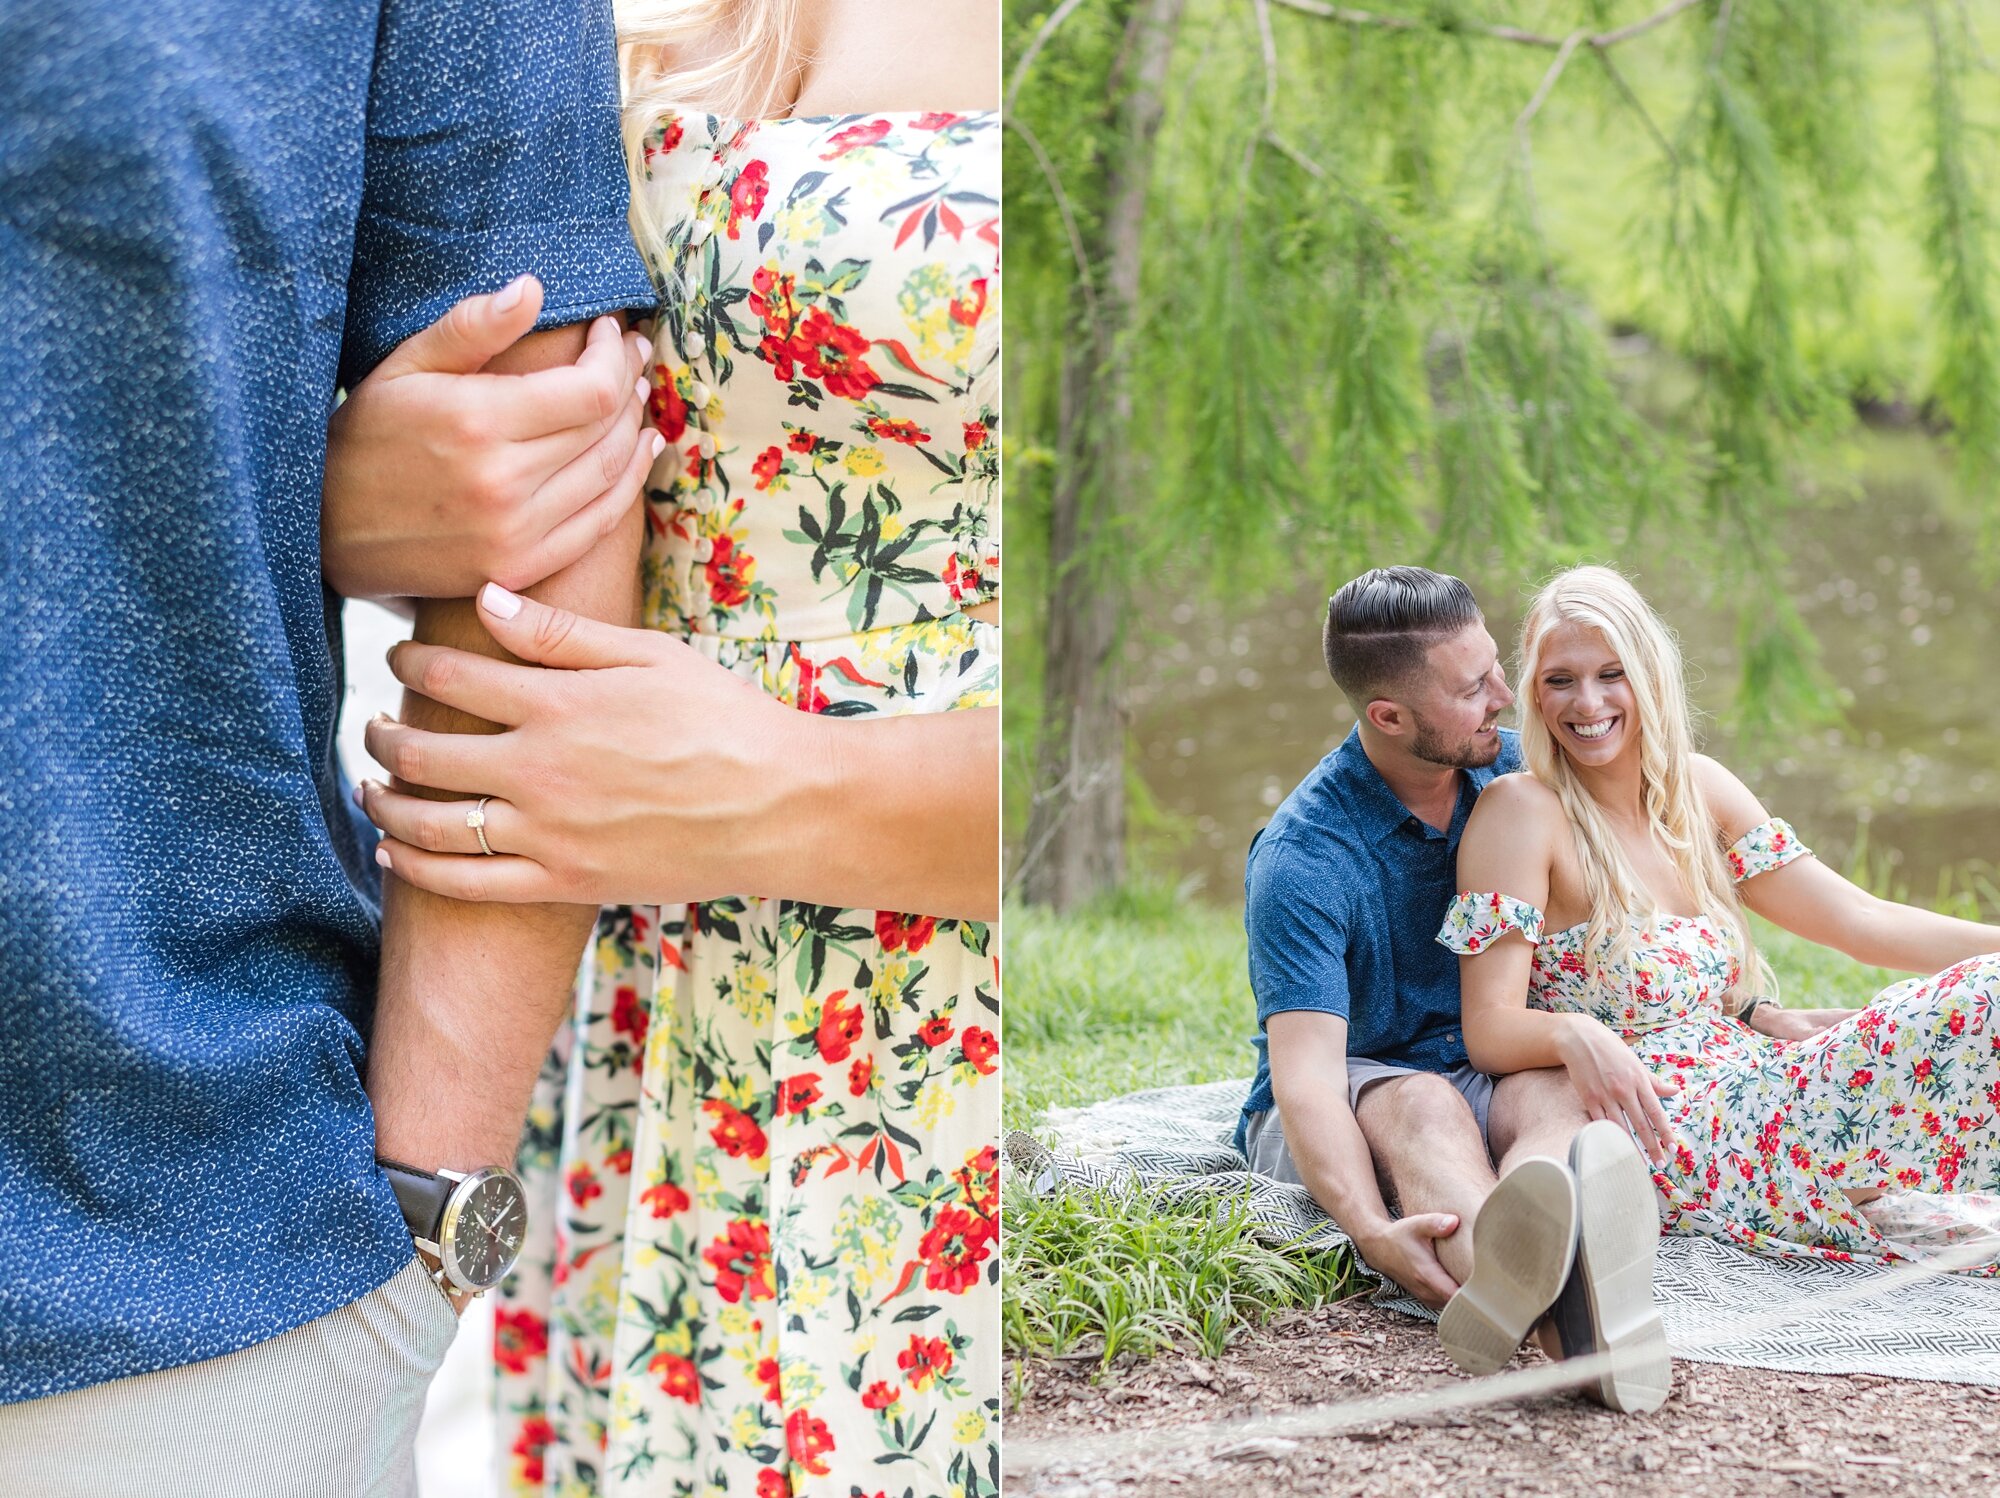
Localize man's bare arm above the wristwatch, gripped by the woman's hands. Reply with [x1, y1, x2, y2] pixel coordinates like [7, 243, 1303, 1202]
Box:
[368, 328, 644, 1170]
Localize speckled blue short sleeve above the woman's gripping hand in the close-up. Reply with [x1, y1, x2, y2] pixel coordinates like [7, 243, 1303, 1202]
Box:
[340, 0, 654, 388]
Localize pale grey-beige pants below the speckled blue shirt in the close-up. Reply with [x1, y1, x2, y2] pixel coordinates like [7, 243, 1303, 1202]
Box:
[0, 1258, 458, 1498]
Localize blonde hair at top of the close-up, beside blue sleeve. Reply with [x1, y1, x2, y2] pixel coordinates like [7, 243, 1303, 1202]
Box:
[612, 0, 810, 280]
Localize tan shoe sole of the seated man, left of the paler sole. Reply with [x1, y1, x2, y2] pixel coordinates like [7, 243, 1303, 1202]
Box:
[1438, 1156, 1578, 1374]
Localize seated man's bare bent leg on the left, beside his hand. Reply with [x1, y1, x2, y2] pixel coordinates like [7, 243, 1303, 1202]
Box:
[1354, 1072, 1496, 1284]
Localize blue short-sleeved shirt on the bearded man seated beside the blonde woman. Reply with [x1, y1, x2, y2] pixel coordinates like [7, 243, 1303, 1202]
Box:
[1236, 728, 1520, 1146]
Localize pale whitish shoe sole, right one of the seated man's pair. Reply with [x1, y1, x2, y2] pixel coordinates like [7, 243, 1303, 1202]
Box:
[1558, 1120, 1674, 1414]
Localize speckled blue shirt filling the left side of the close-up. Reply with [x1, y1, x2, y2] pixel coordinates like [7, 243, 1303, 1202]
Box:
[0, 0, 652, 1400]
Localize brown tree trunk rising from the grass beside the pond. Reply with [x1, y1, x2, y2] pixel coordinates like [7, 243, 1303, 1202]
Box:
[1016, 0, 1184, 910]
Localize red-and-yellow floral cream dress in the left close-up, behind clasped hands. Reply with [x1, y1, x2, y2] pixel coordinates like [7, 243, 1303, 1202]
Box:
[496, 112, 1000, 1498]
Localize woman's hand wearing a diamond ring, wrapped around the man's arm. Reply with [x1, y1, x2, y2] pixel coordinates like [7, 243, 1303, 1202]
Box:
[356, 586, 804, 904]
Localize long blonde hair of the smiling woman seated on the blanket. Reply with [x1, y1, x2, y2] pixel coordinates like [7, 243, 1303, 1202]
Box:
[1518, 566, 1774, 1012]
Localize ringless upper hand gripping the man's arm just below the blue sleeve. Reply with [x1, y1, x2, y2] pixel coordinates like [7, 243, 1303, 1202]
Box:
[320, 276, 666, 598]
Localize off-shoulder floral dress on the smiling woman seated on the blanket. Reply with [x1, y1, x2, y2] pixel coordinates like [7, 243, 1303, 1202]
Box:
[1438, 820, 2000, 1274]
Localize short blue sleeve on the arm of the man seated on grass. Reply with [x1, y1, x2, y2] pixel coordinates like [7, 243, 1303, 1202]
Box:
[1244, 836, 1348, 1030]
